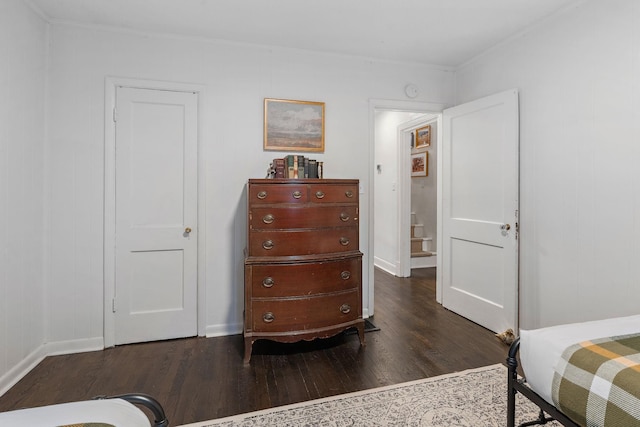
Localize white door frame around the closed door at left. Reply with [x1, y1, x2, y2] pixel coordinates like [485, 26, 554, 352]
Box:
[103, 77, 206, 347]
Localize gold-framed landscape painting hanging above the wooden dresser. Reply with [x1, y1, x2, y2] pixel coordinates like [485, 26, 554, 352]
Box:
[264, 98, 324, 153]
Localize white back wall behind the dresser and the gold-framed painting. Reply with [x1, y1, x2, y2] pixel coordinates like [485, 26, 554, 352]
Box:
[47, 25, 453, 343]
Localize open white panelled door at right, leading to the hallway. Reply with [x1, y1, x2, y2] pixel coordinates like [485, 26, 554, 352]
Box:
[442, 90, 519, 332]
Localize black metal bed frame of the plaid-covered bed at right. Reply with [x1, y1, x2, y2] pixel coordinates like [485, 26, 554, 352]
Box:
[507, 338, 580, 427]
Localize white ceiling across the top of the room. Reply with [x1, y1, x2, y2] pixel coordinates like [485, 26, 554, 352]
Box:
[27, 0, 580, 67]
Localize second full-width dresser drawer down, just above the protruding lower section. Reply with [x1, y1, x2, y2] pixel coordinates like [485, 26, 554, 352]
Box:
[248, 227, 358, 257]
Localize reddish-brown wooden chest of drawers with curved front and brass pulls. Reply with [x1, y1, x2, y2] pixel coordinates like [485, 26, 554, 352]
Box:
[244, 179, 364, 363]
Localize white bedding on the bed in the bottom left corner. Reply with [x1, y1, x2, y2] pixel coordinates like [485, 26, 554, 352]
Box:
[0, 399, 151, 427]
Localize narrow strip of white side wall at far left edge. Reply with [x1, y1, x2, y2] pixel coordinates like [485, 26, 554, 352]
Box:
[0, 0, 47, 394]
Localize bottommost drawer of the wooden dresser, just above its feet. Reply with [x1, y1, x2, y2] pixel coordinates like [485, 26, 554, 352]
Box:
[252, 290, 362, 332]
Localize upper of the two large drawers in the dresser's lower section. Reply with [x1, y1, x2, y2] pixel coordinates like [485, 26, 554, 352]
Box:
[248, 256, 362, 298]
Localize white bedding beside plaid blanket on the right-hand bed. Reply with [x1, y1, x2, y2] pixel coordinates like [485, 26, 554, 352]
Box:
[520, 315, 640, 404]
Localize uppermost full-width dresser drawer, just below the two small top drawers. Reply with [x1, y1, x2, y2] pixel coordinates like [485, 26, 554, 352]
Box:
[249, 205, 358, 230]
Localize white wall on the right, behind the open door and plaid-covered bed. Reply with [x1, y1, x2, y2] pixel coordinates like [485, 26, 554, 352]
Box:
[456, 0, 640, 328]
